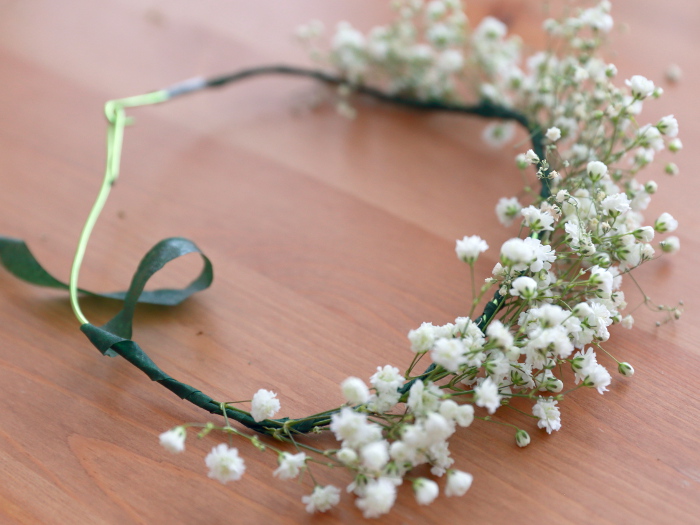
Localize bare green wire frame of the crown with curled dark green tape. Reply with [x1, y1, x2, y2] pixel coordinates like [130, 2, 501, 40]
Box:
[68, 66, 550, 439]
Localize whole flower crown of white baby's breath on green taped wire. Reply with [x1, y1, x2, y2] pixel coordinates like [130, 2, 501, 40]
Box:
[0, 0, 682, 518]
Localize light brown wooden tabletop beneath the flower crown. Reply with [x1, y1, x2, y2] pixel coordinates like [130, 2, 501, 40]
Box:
[0, 0, 700, 524]
